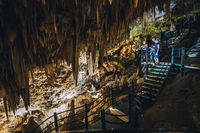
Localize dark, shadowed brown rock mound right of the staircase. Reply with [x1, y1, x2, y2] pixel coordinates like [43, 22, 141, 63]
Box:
[140, 71, 200, 129]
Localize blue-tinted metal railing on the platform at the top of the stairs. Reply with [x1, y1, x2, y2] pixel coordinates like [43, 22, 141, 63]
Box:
[140, 47, 200, 72]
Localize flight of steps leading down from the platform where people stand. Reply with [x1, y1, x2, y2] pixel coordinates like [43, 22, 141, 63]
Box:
[139, 62, 171, 103]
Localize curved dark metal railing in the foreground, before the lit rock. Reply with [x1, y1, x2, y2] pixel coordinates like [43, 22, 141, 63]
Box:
[31, 88, 138, 133]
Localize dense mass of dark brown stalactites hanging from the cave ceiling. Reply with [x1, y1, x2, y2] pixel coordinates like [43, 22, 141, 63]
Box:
[0, 0, 169, 111]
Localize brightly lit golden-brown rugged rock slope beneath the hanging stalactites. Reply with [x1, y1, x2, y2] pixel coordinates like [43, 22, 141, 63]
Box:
[0, 41, 137, 133]
